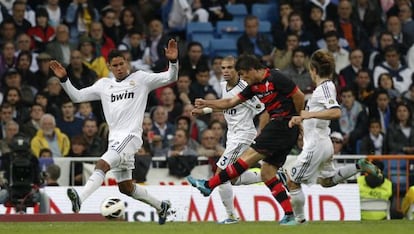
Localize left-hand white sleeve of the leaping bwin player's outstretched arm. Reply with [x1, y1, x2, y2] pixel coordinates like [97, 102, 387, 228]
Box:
[60, 78, 102, 103]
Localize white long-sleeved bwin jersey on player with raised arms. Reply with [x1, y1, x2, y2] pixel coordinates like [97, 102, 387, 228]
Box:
[61, 63, 178, 140]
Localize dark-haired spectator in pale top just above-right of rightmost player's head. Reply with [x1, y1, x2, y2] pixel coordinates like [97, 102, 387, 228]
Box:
[324, 31, 349, 74]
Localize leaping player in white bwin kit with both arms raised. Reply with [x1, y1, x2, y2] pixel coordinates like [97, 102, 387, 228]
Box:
[50, 39, 178, 224]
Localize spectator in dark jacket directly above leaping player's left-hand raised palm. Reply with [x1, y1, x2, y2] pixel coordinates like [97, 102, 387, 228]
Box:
[46, 24, 76, 66]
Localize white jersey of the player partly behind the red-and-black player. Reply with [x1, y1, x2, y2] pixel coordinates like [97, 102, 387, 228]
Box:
[221, 79, 264, 144]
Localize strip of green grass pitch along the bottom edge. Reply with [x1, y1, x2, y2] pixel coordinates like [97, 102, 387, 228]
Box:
[0, 220, 414, 234]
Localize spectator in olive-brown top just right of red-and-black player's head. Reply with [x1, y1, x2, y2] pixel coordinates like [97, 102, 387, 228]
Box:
[273, 33, 299, 70]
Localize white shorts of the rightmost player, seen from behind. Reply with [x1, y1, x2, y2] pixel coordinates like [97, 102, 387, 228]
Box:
[289, 138, 335, 184]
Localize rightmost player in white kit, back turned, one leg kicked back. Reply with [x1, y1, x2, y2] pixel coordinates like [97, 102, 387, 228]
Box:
[288, 50, 382, 225]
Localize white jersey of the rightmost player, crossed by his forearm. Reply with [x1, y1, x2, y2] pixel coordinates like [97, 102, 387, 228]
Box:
[303, 81, 339, 149]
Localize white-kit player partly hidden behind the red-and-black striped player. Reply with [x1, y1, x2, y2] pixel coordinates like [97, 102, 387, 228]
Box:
[192, 56, 264, 224]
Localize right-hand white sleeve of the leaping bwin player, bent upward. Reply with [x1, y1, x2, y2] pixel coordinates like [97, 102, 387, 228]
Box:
[133, 62, 178, 90]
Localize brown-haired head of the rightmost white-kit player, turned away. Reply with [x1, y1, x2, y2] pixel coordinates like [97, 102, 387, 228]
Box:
[309, 49, 335, 79]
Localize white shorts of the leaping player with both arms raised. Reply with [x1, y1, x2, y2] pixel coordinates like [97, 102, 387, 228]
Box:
[101, 135, 142, 183]
